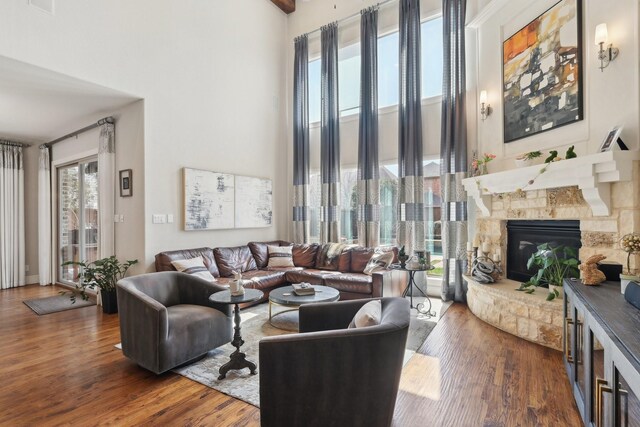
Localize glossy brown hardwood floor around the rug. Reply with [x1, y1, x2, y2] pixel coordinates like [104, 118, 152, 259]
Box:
[0, 286, 580, 427]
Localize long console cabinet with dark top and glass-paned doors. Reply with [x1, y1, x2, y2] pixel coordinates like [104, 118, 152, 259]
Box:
[564, 280, 640, 427]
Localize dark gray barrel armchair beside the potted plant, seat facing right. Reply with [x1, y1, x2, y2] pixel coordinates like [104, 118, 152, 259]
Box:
[116, 271, 232, 374]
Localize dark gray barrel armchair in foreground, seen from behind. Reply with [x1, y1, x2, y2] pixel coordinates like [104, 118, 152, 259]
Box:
[259, 298, 409, 427]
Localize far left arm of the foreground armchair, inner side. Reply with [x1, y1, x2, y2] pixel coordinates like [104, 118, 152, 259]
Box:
[299, 299, 371, 332]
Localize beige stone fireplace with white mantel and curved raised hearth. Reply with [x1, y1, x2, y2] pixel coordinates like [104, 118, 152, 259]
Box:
[464, 152, 640, 350]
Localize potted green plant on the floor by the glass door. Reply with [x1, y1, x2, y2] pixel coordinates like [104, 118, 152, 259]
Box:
[62, 256, 138, 314]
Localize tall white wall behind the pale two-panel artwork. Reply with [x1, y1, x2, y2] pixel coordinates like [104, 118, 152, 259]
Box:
[0, 0, 288, 269]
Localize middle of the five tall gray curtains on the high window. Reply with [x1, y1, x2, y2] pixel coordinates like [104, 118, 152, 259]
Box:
[357, 7, 380, 247]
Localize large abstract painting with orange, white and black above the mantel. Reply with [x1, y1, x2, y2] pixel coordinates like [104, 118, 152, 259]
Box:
[502, 0, 584, 143]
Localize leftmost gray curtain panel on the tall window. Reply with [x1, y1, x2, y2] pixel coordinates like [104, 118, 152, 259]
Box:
[293, 34, 309, 243]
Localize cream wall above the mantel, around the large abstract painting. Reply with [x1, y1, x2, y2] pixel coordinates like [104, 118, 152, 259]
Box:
[469, 0, 640, 172]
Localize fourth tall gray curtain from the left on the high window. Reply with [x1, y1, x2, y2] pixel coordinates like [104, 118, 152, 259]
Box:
[397, 0, 425, 254]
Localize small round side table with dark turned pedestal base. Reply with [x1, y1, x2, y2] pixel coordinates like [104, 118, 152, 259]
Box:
[209, 289, 264, 380]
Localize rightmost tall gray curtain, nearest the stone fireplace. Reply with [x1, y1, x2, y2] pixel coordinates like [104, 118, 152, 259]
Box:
[440, 0, 467, 301]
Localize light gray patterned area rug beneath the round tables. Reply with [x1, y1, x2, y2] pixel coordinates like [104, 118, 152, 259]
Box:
[173, 298, 451, 407]
